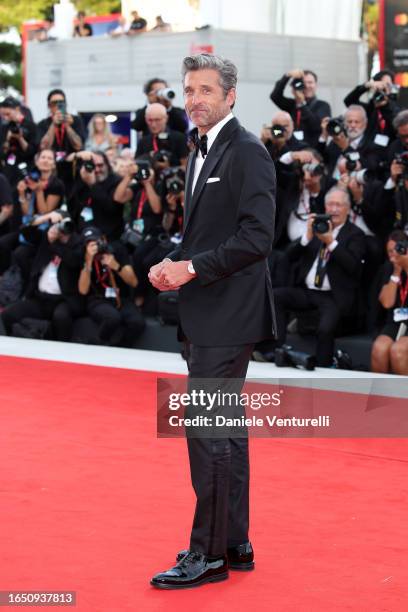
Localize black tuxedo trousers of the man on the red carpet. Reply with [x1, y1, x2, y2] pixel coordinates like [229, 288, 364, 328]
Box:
[186, 342, 254, 556]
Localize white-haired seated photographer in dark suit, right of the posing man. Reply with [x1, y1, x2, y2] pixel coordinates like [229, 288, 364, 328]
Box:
[274, 187, 364, 367]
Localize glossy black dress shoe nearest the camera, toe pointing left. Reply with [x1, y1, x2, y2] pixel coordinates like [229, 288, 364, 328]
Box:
[150, 551, 228, 589]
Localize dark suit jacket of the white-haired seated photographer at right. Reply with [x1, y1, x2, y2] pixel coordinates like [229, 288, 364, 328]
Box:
[289, 221, 365, 314]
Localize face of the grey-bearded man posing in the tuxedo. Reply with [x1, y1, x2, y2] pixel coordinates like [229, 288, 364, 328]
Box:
[184, 68, 235, 133]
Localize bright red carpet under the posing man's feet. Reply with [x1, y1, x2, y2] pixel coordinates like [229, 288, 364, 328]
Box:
[0, 357, 408, 612]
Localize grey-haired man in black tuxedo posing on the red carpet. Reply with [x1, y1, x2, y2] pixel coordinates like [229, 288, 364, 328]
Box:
[149, 54, 275, 588]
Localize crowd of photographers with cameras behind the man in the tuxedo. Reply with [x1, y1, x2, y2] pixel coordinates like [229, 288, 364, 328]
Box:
[0, 70, 408, 374]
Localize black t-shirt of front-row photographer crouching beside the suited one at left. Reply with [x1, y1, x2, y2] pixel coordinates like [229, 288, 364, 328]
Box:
[88, 242, 130, 304]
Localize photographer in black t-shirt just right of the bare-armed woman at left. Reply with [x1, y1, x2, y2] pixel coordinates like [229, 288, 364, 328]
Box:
[68, 151, 129, 241]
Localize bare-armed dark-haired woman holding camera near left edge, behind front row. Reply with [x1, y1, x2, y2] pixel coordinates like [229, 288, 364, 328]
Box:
[0, 149, 64, 281]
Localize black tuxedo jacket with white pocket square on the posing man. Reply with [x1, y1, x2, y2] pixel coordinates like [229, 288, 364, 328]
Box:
[169, 118, 276, 346]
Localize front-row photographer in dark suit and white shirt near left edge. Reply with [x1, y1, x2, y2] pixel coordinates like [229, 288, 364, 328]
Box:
[2, 211, 82, 341]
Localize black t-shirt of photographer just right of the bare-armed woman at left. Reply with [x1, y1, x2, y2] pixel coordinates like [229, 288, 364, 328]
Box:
[68, 173, 124, 241]
